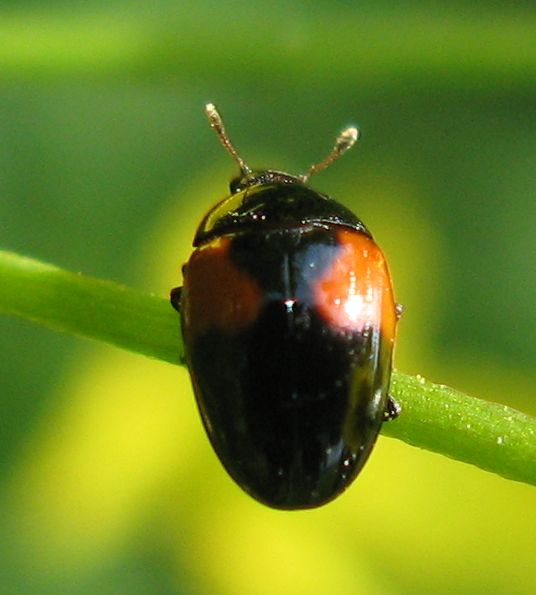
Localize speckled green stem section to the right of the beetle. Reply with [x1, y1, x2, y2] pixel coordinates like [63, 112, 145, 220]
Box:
[382, 372, 536, 485]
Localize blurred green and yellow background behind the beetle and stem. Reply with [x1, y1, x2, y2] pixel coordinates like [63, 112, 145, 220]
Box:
[0, 0, 536, 595]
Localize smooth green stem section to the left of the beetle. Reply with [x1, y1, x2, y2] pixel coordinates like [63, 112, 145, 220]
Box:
[0, 251, 182, 364]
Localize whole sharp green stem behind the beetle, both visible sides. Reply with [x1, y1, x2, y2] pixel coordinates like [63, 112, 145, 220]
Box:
[0, 251, 536, 485]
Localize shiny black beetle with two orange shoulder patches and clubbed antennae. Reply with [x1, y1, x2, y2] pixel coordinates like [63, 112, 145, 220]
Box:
[171, 103, 401, 509]
